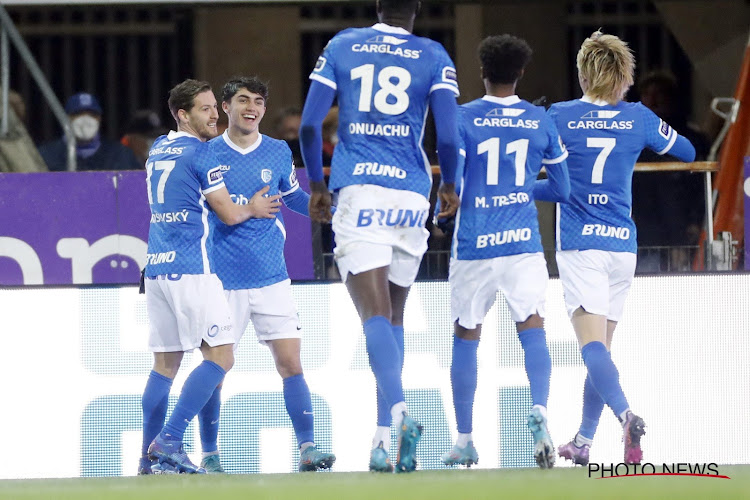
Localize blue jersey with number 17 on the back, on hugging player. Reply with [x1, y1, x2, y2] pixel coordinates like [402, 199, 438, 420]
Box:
[146, 132, 224, 277]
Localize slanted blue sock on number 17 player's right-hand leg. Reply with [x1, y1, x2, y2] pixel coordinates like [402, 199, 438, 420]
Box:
[162, 359, 226, 440]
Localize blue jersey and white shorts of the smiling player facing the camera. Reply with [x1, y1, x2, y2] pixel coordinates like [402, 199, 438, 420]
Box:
[209, 132, 310, 344]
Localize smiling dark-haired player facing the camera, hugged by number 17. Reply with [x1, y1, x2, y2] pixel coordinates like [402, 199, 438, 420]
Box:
[199, 77, 336, 472]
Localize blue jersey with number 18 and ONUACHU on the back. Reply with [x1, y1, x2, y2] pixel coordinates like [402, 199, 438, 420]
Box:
[310, 24, 458, 197]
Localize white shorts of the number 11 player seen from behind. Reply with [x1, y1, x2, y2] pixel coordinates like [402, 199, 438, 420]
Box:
[449, 252, 549, 329]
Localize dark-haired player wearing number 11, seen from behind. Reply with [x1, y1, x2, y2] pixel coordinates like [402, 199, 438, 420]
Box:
[442, 35, 570, 469]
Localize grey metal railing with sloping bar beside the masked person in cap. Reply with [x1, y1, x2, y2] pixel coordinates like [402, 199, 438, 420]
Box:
[0, 5, 76, 172]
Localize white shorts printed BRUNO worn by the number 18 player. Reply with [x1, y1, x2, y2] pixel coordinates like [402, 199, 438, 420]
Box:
[333, 184, 430, 287]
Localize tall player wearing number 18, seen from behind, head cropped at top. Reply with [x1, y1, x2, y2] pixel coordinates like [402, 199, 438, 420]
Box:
[300, 0, 458, 472]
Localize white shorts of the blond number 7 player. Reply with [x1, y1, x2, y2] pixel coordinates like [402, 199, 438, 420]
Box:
[557, 250, 636, 321]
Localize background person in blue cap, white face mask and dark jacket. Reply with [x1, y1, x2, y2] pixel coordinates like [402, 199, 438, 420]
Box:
[39, 92, 142, 172]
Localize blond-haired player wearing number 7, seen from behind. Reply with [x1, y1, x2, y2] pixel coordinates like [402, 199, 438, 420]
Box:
[549, 31, 695, 465]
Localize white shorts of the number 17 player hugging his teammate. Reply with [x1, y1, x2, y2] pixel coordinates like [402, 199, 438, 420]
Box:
[145, 274, 234, 352]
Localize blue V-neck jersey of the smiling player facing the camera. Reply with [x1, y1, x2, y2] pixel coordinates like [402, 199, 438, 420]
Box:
[209, 132, 299, 290]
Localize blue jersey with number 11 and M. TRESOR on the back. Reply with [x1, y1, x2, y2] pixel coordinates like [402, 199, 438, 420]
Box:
[452, 96, 567, 260]
